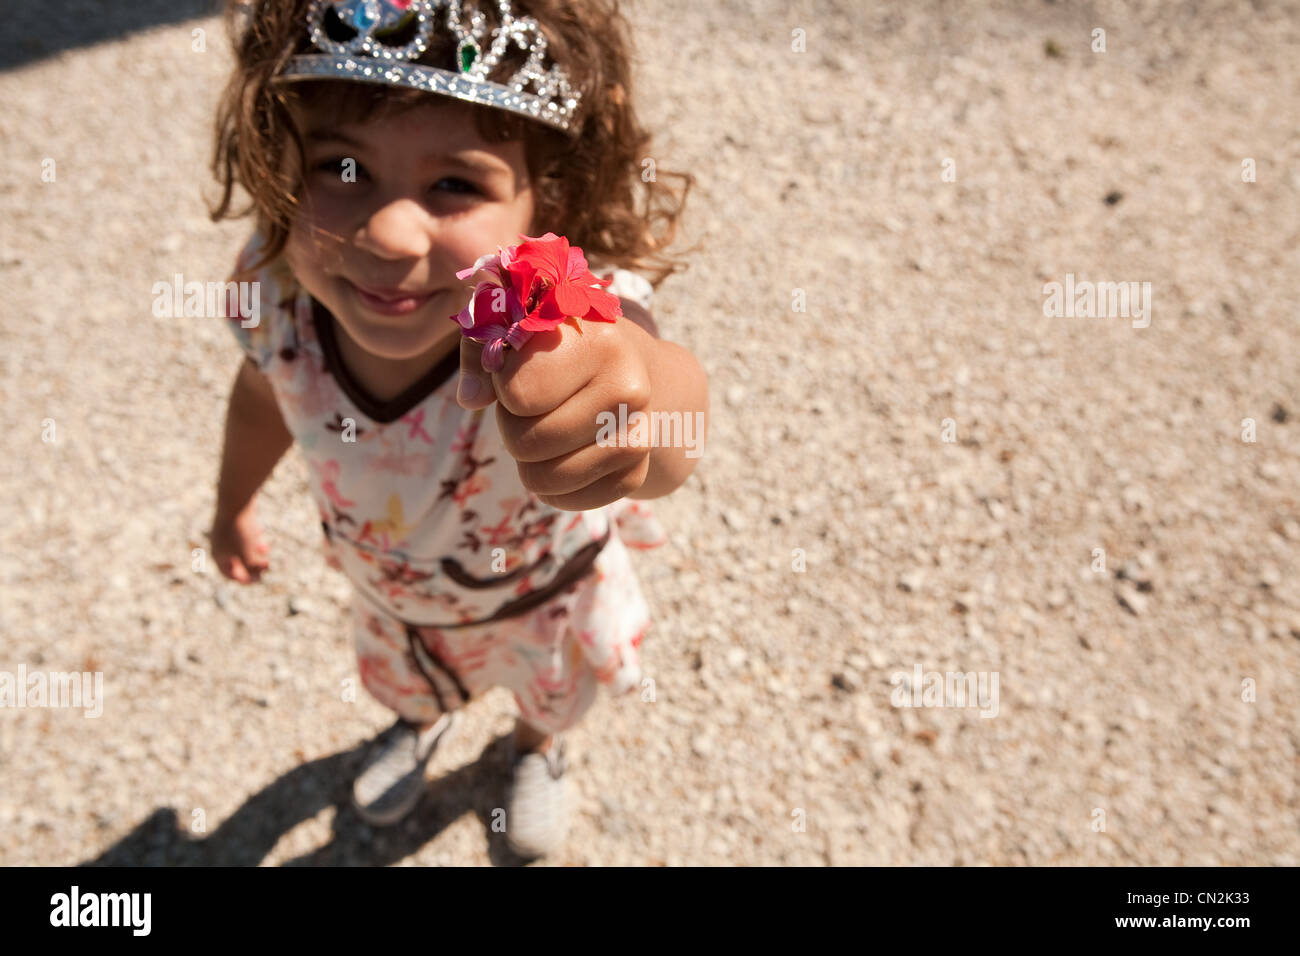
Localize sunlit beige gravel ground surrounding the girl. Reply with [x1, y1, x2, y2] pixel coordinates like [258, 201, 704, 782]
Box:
[0, 0, 1300, 865]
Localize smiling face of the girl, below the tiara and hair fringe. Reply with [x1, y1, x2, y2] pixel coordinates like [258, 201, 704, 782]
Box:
[286, 96, 533, 360]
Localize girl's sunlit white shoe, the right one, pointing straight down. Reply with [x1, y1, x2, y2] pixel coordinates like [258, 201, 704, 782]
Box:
[506, 734, 568, 860]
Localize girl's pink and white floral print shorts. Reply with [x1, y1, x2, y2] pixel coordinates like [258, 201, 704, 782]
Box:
[352, 535, 650, 734]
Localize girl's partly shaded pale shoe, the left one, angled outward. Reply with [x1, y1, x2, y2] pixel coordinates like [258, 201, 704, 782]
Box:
[352, 710, 460, 826]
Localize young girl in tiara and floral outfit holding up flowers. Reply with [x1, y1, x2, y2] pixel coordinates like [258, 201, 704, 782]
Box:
[211, 0, 709, 857]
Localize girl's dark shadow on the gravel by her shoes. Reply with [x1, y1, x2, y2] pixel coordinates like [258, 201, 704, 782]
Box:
[81, 736, 538, 866]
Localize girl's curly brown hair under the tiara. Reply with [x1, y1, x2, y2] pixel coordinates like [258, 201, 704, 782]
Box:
[209, 0, 696, 287]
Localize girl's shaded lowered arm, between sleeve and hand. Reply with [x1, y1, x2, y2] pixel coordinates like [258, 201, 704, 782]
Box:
[216, 362, 294, 520]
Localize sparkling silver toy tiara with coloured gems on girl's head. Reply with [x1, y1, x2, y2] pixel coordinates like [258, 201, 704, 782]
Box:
[276, 0, 582, 133]
